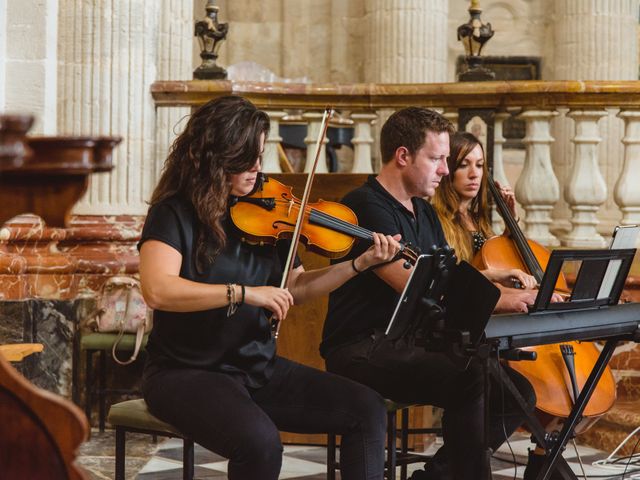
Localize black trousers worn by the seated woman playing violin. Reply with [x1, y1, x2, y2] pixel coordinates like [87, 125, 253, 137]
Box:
[143, 357, 386, 480]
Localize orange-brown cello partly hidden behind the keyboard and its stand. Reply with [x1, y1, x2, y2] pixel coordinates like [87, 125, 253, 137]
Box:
[472, 176, 616, 434]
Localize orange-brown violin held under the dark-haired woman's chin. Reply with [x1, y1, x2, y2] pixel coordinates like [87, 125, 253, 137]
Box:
[230, 173, 419, 268]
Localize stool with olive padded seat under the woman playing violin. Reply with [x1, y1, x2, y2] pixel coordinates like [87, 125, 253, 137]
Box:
[107, 399, 194, 480]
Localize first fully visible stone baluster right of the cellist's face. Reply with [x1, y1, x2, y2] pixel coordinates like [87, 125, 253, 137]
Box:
[515, 110, 560, 246]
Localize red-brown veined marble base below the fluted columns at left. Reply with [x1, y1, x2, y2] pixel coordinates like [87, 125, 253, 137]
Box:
[0, 215, 144, 300]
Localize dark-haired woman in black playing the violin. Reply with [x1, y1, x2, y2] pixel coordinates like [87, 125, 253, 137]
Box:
[139, 96, 399, 480]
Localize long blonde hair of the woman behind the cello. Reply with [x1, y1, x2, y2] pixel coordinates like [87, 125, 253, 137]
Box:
[431, 132, 494, 262]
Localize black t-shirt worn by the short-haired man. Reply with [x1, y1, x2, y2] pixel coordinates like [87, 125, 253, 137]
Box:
[320, 175, 447, 357]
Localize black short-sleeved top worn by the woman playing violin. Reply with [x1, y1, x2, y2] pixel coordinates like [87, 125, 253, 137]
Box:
[138, 196, 299, 387]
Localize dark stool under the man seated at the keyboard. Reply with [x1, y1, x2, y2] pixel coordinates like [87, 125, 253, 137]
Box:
[327, 399, 441, 480]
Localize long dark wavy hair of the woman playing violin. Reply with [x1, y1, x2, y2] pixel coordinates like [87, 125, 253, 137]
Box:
[150, 96, 269, 269]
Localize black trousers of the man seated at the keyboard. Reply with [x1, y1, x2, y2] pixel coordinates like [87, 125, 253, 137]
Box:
[325, 334, 535, 480]
